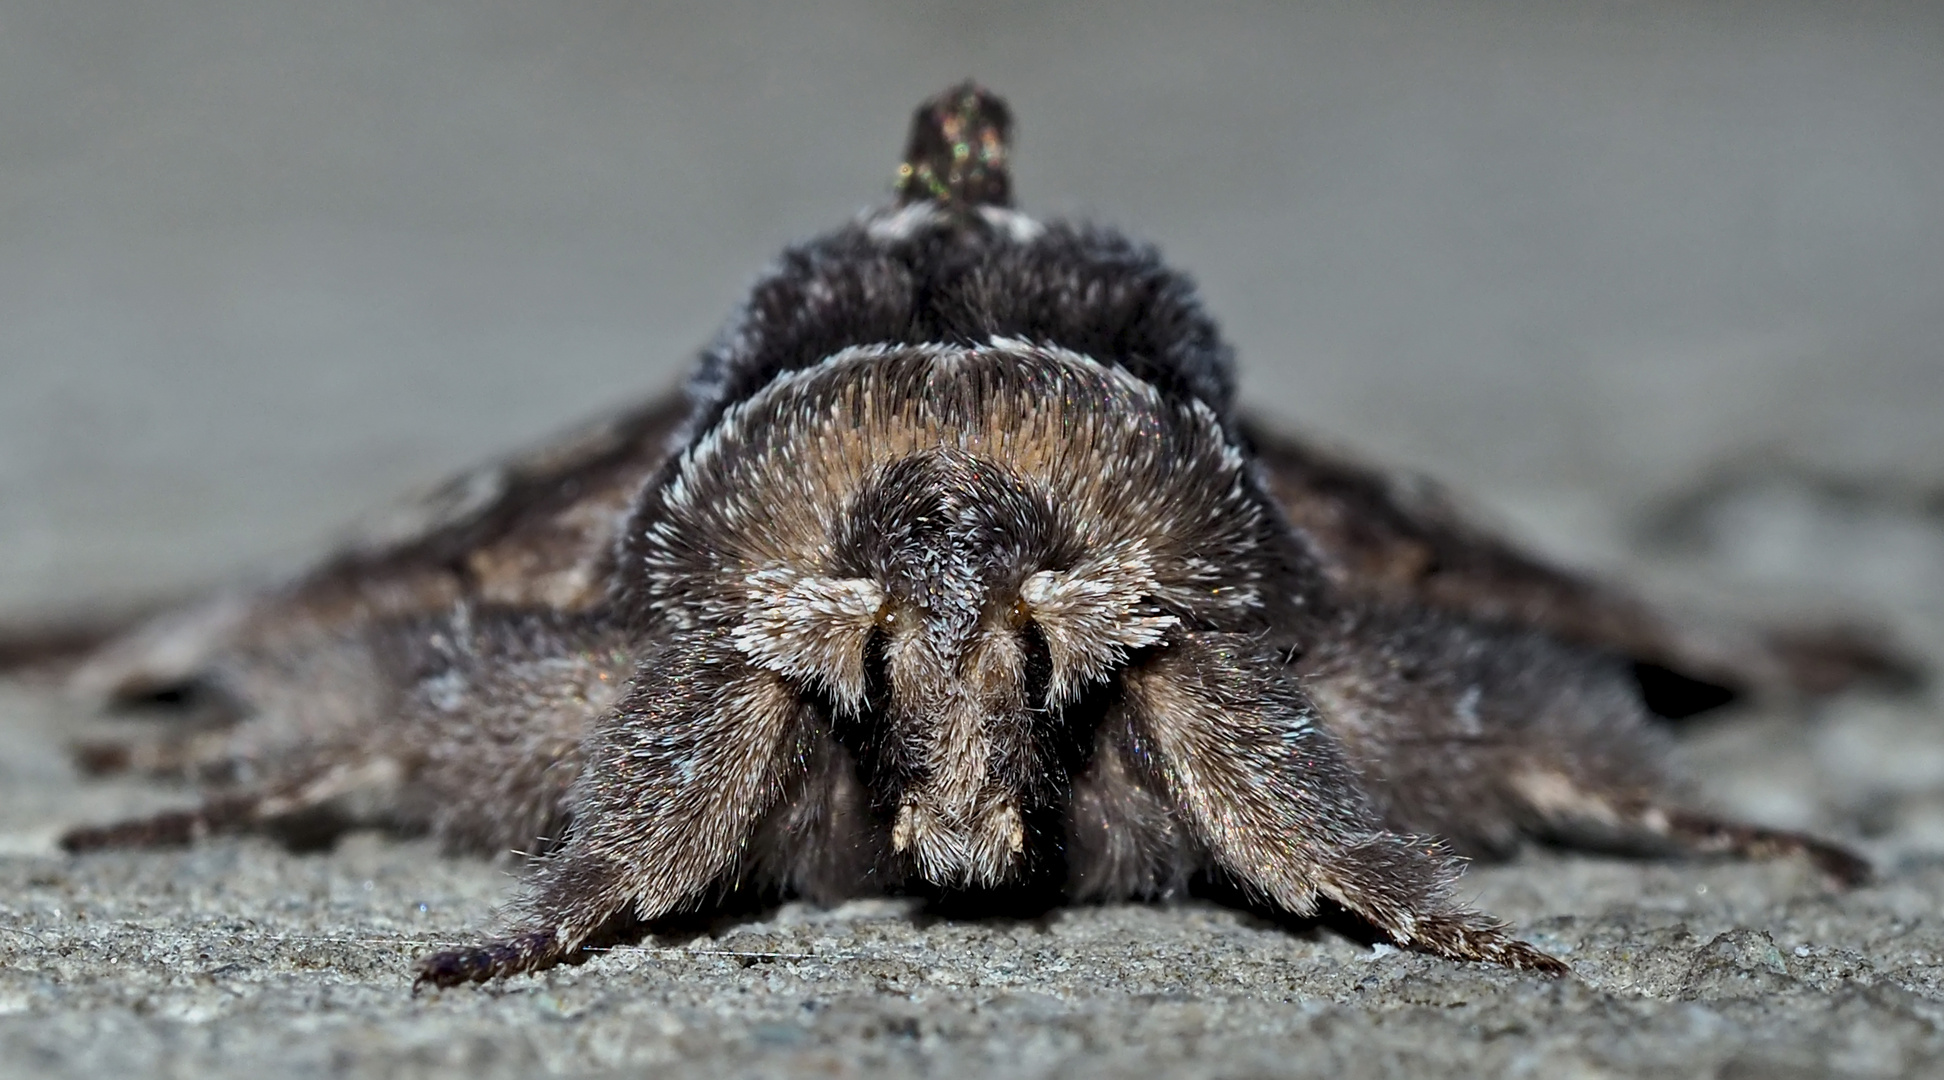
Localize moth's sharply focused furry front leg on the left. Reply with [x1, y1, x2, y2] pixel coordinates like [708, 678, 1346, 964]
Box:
[418, 631, 809, 987]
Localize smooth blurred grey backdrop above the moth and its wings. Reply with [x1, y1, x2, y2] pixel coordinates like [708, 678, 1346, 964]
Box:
[0, 0, 1944, 616]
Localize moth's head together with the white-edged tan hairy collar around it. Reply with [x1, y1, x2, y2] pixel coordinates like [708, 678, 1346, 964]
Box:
[626, 340, 1277, 888]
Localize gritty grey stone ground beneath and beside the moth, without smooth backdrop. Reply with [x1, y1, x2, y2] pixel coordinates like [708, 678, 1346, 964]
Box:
[0, 476, 1944, 1080]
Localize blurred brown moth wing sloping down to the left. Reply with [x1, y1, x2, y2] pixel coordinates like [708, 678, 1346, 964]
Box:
[74, 394, 688, 699]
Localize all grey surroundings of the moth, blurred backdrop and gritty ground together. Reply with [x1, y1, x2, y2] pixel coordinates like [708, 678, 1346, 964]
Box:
[0, 0, 1944, 1078]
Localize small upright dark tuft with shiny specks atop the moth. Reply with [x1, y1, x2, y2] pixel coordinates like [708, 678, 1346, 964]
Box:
[898, 80, 1013, 210]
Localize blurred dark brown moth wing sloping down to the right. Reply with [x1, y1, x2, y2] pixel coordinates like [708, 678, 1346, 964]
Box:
[1242, 420, 1919, 717]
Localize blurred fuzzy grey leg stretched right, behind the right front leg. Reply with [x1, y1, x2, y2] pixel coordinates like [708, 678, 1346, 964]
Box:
[1301, 606, 1868, 884]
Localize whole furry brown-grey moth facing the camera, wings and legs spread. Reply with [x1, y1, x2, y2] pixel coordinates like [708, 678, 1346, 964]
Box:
[45, 84, 1893, 987]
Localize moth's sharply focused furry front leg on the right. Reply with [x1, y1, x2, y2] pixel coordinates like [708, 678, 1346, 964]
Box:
[1124, 633, 1567, 973]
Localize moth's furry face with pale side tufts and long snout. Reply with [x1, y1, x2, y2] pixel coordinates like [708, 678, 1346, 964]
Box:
[733, 447, 1176, 886]
